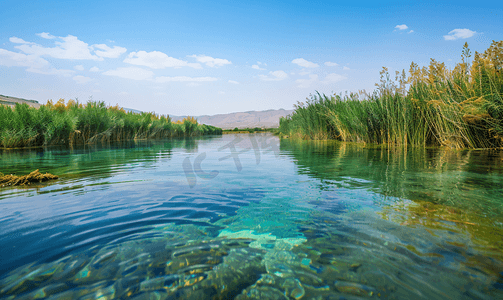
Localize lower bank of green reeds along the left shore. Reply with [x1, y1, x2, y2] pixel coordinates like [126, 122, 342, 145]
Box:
[0, 99, 222, 149]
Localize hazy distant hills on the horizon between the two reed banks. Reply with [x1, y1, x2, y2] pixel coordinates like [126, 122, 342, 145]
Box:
[170, 109, 293, 129]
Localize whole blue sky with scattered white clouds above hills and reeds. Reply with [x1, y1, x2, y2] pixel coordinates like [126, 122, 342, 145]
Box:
[0, 0, 503, 115]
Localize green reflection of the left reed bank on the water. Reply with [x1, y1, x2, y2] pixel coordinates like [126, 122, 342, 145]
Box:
[0, 136, 216, 178]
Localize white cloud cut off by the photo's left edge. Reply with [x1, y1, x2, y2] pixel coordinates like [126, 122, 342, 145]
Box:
[0, 49, 74, 76]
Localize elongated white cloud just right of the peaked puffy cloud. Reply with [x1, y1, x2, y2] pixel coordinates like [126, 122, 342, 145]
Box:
[124, 51, 202, 69]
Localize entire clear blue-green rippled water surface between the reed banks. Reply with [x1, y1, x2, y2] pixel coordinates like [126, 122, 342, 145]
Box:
[0, 134, 503, 299]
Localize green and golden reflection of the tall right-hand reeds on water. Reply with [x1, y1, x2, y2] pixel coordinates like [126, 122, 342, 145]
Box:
[280, 140, 503, 217]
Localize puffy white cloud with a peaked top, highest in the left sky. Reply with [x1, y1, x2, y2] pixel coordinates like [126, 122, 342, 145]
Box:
[15, 35, 103, 60]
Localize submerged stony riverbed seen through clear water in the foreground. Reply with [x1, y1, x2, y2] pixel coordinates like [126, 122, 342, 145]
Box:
[2, 220, 365, 300]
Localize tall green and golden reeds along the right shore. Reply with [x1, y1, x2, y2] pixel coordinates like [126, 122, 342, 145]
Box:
[279, 41, 503, 149]
